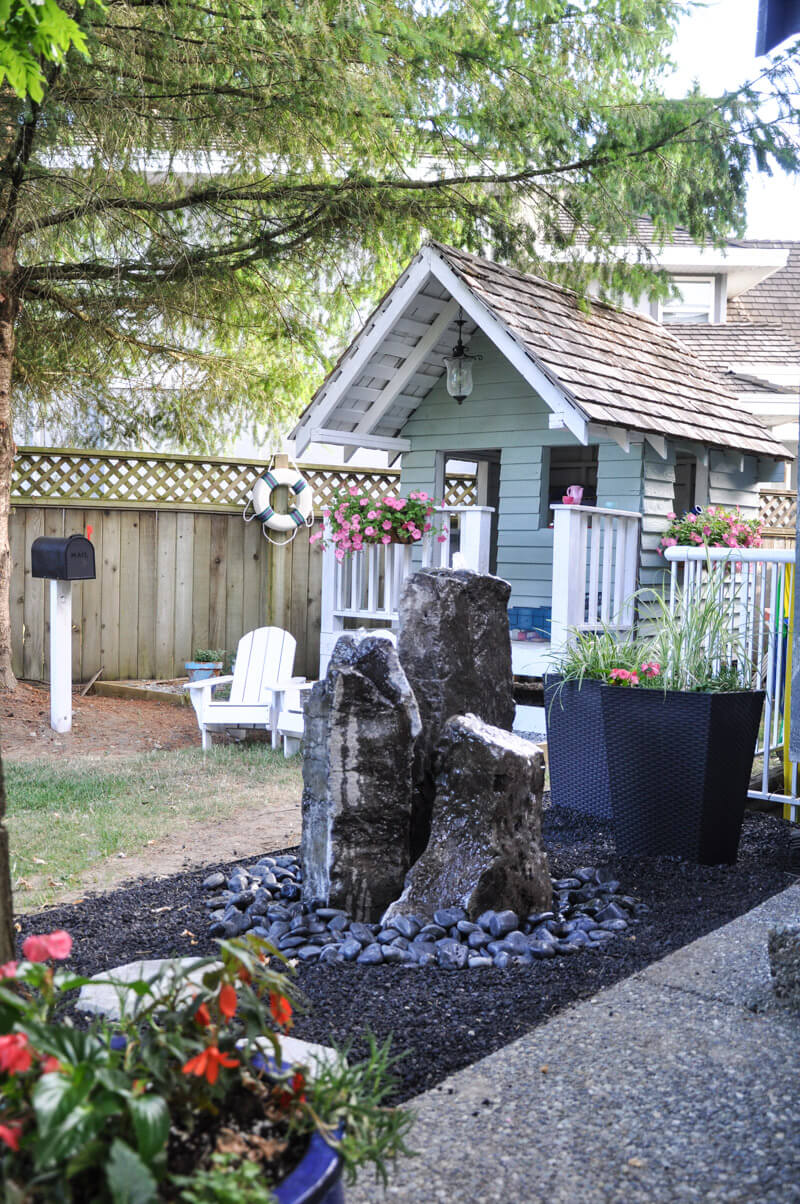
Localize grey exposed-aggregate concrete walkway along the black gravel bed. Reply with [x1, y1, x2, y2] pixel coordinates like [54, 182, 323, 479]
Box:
[347, 884, 800, 1204]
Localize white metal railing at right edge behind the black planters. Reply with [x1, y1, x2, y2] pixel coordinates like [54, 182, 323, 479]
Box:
[664, 548, 800, 820]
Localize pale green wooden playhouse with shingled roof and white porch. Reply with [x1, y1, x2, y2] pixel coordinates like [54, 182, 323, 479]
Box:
[293, 243, 792, 675]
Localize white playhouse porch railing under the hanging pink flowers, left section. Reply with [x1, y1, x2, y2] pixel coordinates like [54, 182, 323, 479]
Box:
[319, 506, 493, 677]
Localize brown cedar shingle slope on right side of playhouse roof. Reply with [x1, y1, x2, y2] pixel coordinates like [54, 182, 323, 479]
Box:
[431, 243, 788, 459]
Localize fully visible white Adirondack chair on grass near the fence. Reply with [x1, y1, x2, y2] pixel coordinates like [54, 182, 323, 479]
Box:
[186, 627, 305, 750]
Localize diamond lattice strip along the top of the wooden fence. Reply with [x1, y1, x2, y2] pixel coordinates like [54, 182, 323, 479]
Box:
[11, 448, 476, 512]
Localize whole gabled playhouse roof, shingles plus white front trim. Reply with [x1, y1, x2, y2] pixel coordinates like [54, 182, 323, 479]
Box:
[294, 243, 790, 459]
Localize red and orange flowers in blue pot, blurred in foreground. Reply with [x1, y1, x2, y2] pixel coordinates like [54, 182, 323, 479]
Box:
[0, 932, 411, 1204]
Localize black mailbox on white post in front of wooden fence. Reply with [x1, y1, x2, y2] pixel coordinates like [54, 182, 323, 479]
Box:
[30, 535, 95, 732]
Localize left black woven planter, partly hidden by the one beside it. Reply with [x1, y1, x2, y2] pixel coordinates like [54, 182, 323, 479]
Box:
[545, 673, 611, 820]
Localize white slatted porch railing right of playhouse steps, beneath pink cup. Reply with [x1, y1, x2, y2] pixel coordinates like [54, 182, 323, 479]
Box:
[551, 506, 642, 648]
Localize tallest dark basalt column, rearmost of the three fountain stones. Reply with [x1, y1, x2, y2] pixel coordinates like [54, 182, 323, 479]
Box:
[398, 568, 514, 860]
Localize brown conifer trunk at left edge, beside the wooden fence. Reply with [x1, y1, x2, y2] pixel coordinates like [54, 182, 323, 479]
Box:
[0, 239, 19, 693]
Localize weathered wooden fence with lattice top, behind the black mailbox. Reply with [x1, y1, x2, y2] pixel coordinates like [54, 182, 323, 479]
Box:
[10, 448, 475, 681]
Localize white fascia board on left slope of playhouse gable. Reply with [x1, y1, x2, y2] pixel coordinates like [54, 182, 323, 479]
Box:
[292, 255, 429, 455]
